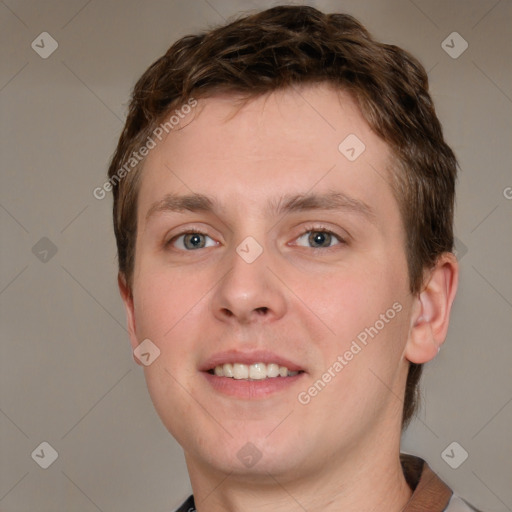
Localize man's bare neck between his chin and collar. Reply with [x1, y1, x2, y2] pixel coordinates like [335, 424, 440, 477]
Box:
[186, 438, 412, 512]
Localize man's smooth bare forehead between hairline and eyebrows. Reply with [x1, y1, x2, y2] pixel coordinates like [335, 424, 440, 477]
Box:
[138, 84, 394, 222]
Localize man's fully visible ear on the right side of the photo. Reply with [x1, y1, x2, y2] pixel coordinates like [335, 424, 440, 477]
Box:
[404, 253, 459, 364]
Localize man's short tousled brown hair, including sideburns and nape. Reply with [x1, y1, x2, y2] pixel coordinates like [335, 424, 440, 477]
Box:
[108, 6, 457, 428]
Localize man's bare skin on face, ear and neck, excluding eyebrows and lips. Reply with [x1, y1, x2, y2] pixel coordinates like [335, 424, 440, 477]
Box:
[119, 84, 458, 512]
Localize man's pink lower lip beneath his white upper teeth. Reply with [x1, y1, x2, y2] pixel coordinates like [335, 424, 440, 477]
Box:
[202, 372, 305, 399]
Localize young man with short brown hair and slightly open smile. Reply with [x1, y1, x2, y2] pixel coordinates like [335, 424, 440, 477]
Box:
[109, 6, 475, 512]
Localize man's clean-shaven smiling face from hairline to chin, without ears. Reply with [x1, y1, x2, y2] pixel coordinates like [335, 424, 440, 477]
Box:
[123, 85, 412, 479]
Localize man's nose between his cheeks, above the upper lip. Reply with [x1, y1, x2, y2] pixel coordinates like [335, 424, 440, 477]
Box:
[212, 239, 286, 324]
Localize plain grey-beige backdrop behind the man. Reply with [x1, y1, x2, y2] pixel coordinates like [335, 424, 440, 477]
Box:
[0, 0, 512, 512]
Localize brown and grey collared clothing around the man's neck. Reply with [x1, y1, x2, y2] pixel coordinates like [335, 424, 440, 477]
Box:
[173, 453, 479, 512]
